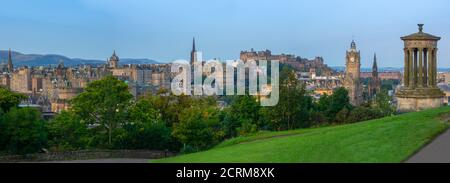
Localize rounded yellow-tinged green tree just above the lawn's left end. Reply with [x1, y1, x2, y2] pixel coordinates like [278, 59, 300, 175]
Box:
[172, 106, 224, 151]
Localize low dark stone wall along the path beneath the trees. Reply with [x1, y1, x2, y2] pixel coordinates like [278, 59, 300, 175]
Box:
[0, 150, 176, 162]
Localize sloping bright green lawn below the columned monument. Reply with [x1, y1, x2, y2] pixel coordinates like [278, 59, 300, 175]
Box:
[151, 107, 450, 163]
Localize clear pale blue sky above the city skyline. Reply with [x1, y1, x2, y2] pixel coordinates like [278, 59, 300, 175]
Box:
[0, 0, 450, 67]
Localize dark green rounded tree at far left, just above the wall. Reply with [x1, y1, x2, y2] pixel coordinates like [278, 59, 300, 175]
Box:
[0, 108, 47, 154]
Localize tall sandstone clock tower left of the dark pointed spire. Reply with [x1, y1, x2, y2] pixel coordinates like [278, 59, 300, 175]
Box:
[344, 41, 362, 106]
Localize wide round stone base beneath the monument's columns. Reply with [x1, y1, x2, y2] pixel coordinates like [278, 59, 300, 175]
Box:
[396, 88, 445, 112]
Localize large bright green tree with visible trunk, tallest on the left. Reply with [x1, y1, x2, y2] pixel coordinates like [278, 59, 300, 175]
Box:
[71, 76, 133, 145]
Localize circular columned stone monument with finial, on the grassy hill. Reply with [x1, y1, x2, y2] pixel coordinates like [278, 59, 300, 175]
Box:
[395, 24, 445, 112]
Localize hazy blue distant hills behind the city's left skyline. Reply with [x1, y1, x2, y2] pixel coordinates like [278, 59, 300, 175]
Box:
[0, 50, 159, 67]
